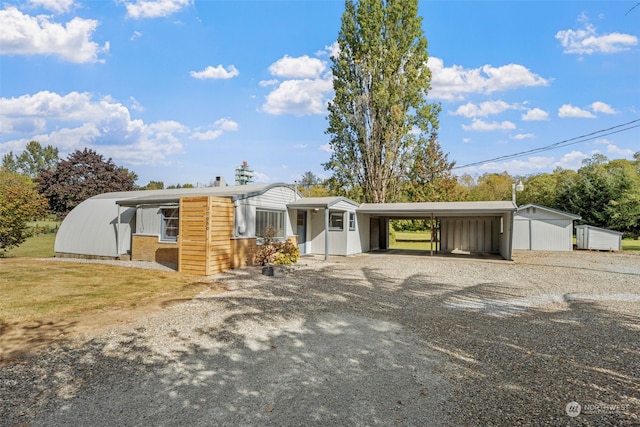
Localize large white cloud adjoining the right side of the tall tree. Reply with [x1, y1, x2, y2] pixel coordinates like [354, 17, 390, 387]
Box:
[427, 56, 549, 100]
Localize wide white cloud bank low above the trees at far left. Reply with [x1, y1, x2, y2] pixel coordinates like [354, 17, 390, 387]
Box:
[0, 91, 189, 165]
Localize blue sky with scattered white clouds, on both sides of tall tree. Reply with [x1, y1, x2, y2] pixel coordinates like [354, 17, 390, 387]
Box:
[0, 0, 640, 185]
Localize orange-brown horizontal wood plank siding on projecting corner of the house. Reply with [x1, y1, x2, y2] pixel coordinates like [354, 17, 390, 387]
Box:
[178, 196, 233, 276]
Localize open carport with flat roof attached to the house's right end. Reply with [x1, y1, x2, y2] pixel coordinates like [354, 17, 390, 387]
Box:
[358, 201, 517, 260]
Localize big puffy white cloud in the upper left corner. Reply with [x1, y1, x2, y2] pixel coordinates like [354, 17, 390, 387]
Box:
[0, 7, 109, 63]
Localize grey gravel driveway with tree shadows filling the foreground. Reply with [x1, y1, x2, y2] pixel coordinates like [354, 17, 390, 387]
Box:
[0, 252, 640, 426]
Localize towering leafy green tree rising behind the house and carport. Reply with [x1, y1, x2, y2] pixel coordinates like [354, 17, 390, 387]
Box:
[324, 0, 440, 202]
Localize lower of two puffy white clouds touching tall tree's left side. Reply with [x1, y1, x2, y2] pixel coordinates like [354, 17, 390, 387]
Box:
[262, 79, 333, 116]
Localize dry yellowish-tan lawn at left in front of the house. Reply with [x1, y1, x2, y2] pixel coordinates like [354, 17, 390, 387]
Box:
[0, 258, 209, 325]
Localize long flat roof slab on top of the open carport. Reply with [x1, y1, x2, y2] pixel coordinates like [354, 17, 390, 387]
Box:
[358, 201, 517, 218]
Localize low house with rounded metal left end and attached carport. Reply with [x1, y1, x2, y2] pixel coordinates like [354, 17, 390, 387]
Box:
[55, 184, 516, 275]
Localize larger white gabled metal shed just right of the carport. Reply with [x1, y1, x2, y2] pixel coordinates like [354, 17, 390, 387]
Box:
[513, 203, 580, 251]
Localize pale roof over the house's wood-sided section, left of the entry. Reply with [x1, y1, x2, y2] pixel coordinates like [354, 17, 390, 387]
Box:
[115, 183, 302, 206]
